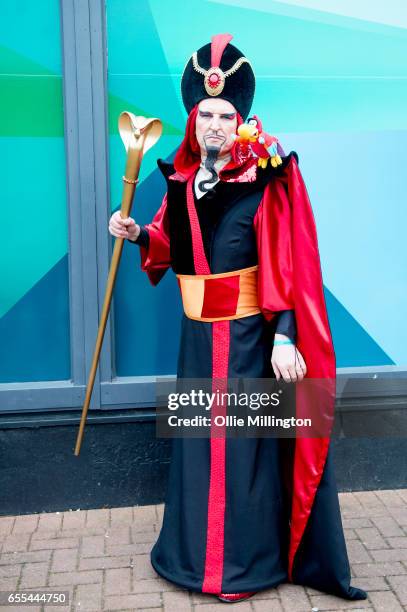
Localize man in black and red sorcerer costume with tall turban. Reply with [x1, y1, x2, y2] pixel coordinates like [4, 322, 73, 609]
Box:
[109, 34, 366, 602]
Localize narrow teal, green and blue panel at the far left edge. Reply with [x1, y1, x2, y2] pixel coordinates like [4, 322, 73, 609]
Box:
[0, 0, 70, 382]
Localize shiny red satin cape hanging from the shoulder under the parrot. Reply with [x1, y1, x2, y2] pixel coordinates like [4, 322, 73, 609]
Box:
[255, 154, 336, 580]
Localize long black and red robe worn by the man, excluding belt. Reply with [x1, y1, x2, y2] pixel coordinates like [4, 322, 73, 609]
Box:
[130, 137, 366, 599]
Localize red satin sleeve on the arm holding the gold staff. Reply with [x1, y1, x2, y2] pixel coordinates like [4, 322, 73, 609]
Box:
[140, 194, 171, 285]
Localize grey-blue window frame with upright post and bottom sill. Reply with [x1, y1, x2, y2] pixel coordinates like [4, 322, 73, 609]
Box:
[0, 0, 407, 414]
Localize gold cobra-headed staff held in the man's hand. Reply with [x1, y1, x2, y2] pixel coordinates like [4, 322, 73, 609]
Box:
[75, 111, 162, 456]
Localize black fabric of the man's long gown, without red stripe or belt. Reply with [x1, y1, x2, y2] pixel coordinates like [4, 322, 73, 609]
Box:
[131, 156, 366, 599]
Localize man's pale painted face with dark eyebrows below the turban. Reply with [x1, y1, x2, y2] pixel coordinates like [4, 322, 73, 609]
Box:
[195, 98, 237, 157]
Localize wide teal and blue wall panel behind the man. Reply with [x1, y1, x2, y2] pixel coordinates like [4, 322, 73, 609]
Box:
[106, 0, 407, 375]
